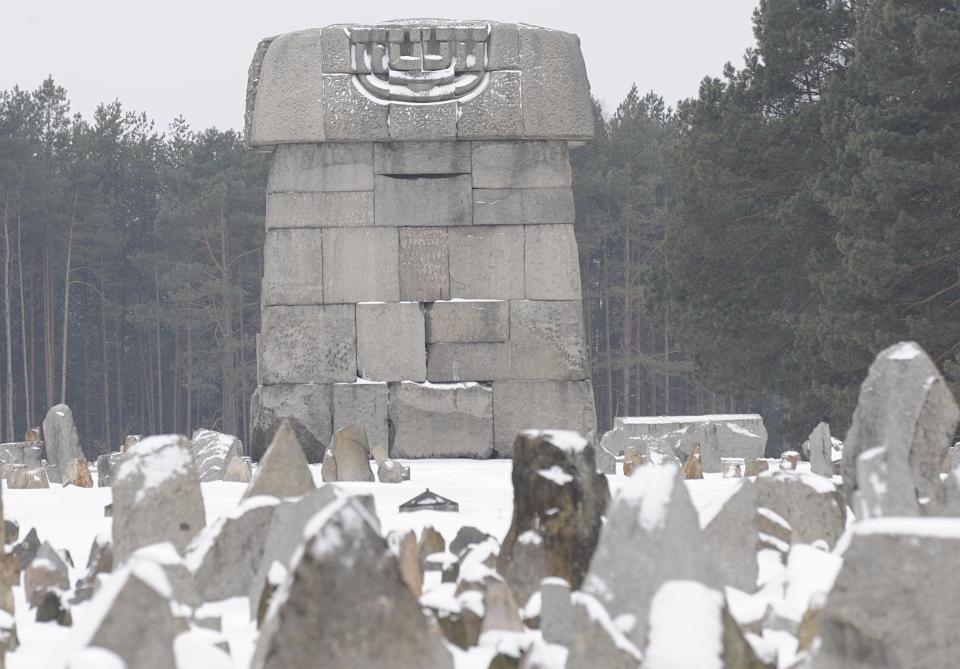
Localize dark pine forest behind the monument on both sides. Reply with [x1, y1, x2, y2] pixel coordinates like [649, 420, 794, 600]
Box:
[0, 0, 960, 456]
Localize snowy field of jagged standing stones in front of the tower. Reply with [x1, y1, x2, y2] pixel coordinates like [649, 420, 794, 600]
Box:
[0, 343, 960, 669]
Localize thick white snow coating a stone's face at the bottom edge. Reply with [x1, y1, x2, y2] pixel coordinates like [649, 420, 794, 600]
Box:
[643, 581, 723, 669]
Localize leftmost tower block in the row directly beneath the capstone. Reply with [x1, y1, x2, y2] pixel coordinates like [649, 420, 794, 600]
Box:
[267, 143, 373, 193]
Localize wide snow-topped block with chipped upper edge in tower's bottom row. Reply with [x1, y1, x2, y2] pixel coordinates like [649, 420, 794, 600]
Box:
[389, 383, 493, 458]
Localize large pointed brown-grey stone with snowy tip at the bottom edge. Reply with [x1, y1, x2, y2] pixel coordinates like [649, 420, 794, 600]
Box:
[251, 498, 453, 669]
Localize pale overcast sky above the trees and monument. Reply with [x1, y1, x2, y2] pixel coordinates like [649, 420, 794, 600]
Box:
[0, 0, 757, 129]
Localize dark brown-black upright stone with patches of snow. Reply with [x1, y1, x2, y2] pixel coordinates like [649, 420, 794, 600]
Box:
[497, 430, 610, 605]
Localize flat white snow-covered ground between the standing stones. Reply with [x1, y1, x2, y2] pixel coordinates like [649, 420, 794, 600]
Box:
[3, 460, 784, 669]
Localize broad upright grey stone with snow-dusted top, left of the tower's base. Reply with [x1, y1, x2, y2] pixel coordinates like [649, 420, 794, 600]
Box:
[112, 435, 206, 563]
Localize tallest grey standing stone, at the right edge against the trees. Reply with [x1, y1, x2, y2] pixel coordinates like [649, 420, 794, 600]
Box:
[841, 342, 960, 516]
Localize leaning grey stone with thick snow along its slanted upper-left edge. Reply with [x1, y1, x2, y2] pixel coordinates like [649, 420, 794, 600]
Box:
[185, 495, 280, 601]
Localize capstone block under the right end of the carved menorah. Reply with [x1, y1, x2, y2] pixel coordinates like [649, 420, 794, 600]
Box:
[456, 72, 523, 139]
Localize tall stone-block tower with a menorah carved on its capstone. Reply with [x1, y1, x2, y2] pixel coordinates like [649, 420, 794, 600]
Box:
[246, 19, 596, 461]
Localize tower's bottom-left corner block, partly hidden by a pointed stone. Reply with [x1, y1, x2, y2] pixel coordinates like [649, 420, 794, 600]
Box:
[250, 384, 333, 462]
